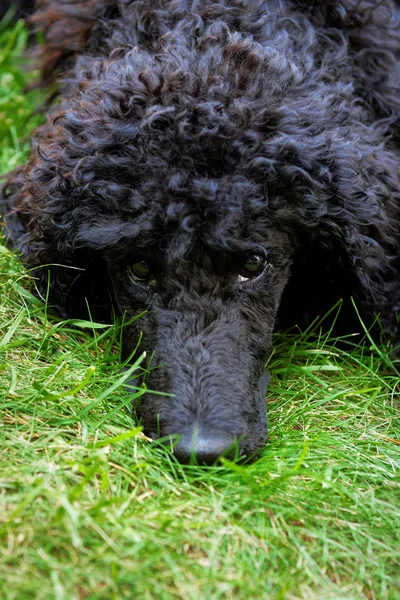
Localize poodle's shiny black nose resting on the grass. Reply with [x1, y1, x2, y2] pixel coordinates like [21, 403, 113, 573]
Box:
[170, 426, 239, 465]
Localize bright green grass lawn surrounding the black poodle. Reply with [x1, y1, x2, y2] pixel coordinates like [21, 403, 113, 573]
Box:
[0, 19, 400, 600]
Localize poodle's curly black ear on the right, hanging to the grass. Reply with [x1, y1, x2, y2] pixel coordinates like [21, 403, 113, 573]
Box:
[280, 133, 400, 335]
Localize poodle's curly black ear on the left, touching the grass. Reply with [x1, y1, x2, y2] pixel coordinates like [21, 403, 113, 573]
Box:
[0, 167, 112, 321]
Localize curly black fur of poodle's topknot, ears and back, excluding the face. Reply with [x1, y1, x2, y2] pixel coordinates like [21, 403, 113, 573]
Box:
[3, 0, 400, 334]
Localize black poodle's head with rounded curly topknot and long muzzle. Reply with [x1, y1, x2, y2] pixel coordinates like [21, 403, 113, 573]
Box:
[10, 34, 396, 462]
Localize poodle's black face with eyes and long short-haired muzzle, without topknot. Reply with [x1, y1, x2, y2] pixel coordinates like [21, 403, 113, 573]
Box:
[74, 158, 292, 462]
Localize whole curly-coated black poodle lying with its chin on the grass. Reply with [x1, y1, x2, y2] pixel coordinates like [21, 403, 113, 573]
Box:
[1, 0, 400, 463]
